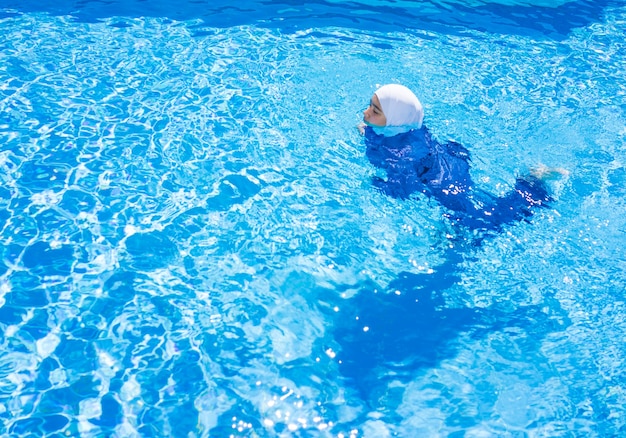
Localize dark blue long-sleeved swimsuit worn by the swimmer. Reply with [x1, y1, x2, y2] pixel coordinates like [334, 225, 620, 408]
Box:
[365, 126, 552, 230]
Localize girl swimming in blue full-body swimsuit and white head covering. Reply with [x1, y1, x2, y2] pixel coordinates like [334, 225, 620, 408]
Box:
[359, 84, 561, 230]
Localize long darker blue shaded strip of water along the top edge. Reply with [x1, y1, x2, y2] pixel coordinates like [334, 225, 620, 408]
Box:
[0, 0, 622, 40]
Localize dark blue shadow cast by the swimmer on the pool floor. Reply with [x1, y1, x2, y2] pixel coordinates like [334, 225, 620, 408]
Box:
[334, 246, 567, 400]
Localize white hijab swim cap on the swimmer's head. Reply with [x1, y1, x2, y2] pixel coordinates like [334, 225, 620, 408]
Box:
[376, 84, 424, 131]
